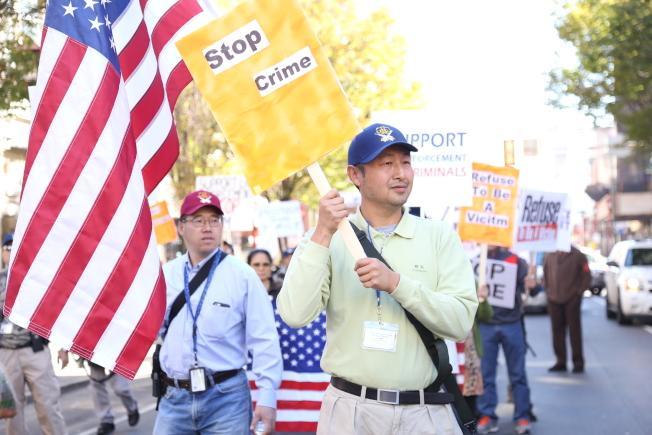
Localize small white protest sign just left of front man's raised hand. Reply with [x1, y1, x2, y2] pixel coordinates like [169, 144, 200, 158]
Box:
[256, 201, 305, 237]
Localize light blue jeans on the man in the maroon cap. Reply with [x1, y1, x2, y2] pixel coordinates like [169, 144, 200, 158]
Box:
[153, 371, 252, 435]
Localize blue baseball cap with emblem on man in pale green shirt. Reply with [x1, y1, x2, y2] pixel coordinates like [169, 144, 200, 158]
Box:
[349, 124, 419, 165]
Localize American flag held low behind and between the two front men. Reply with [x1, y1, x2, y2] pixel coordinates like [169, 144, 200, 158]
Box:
[247, 300, 331, 432]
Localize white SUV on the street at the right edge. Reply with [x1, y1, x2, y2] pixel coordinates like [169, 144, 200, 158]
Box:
[605, 240, 652, 324]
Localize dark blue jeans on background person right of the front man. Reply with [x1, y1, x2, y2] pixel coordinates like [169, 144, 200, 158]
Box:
[478, 320, 530, 421]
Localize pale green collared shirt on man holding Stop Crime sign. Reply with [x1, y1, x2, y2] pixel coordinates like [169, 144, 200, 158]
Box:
[277, 211, 478, 390]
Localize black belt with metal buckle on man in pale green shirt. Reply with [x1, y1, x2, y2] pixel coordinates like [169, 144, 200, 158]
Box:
[331, 377, 453, 405]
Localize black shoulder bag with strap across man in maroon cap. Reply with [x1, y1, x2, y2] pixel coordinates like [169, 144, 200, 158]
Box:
[151, 250, 227, 411]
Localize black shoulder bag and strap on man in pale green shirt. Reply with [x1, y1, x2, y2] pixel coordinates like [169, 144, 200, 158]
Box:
[351, 223, 477, 435]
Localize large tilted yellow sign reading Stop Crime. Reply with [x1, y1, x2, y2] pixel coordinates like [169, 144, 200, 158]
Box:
[177, 0, 359, 193]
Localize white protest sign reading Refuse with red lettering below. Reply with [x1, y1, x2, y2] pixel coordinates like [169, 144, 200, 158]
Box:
[514, 189, 570, 252]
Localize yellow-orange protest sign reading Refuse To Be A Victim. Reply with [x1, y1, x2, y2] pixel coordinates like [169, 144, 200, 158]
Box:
[458, 163, 518, 247]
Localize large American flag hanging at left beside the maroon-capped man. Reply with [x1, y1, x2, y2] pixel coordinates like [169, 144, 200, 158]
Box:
[4, 0, 211, 378]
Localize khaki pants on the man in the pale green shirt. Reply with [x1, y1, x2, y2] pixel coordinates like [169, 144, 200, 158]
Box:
[317, 385, 462, 435]
